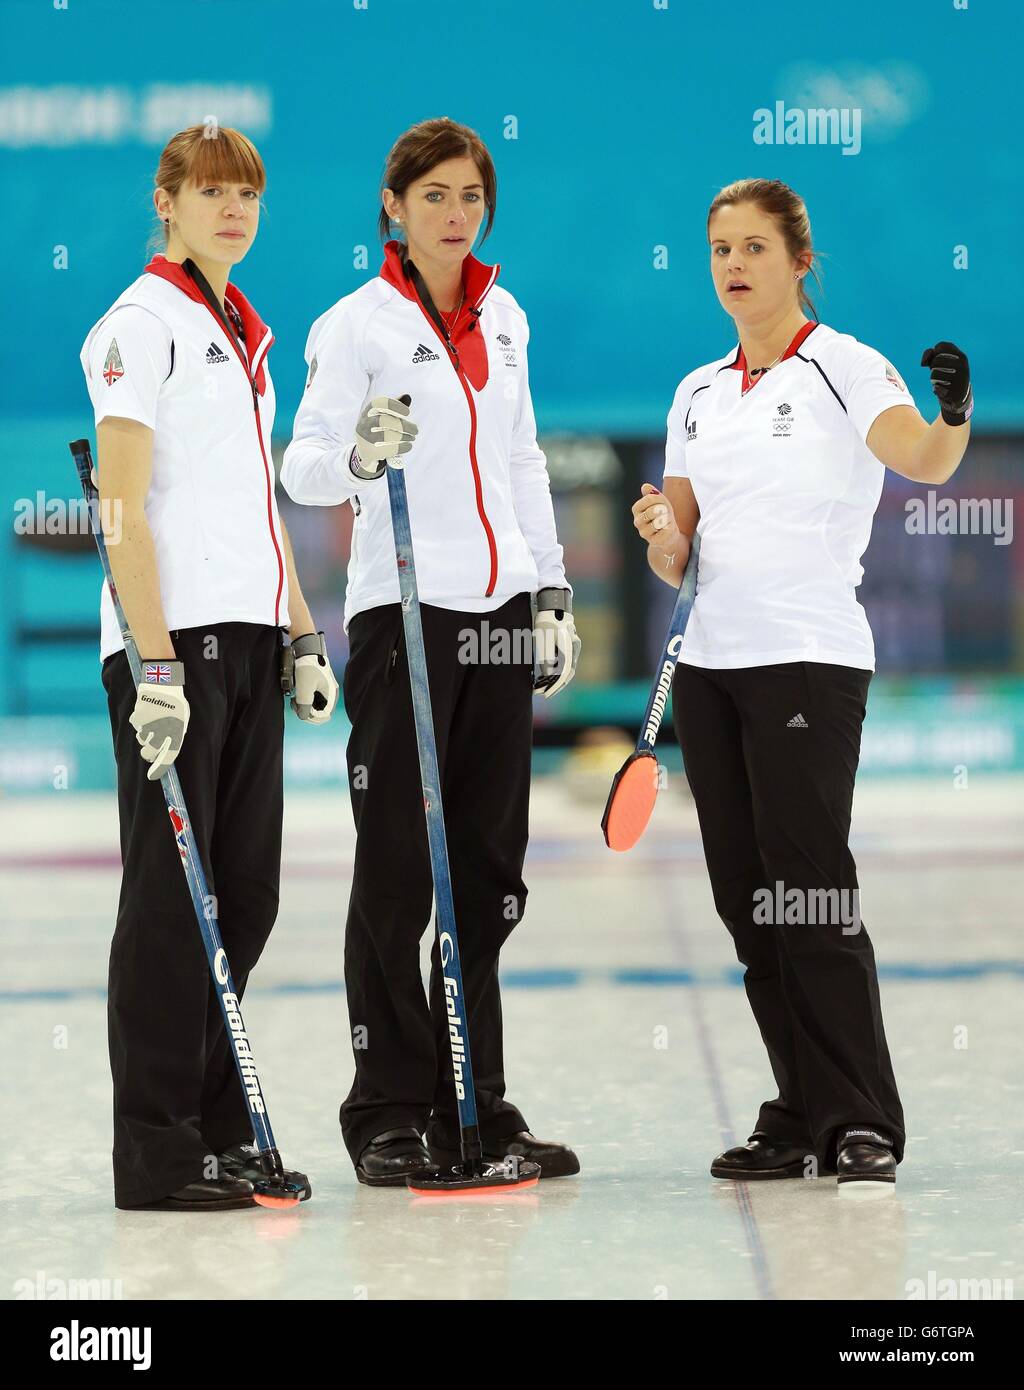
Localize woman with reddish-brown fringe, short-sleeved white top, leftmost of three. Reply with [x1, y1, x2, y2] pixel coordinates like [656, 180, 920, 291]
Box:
[82, 125, 338, 1211]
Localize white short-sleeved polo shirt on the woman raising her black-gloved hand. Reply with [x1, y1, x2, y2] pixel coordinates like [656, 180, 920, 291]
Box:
[666, 324, 914, 670]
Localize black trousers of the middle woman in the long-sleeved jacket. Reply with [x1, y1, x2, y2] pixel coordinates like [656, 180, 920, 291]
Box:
[340, 594, 534, 1162]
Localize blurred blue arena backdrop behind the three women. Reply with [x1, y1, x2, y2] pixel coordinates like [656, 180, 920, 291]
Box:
[0, 0, 1024, 790]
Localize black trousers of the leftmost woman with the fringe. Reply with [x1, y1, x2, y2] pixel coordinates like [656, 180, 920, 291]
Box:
[103, 623, 283, 1207]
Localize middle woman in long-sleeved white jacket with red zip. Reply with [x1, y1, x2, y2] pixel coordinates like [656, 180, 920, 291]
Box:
[281, 118, 579, 1186]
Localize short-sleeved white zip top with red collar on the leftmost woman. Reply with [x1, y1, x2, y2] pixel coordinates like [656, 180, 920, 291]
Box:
[82, 256, 288, 660]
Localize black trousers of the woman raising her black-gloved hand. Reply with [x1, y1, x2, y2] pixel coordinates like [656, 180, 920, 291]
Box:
[672, 662, 905, 1166]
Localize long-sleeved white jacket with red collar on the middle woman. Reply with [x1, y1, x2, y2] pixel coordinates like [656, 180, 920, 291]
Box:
[281, 242, 568, 628]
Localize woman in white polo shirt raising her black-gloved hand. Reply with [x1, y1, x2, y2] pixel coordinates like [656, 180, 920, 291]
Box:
[632, 179, 973, 1191]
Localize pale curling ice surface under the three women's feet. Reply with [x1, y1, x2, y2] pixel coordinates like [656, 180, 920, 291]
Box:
[0, 778, 1024, 1300]
